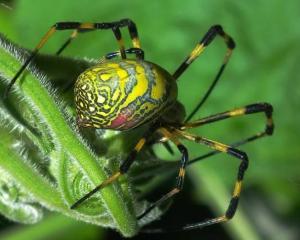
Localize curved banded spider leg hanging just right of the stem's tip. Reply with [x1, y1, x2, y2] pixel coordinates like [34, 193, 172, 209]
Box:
[138, 128, 189, 219]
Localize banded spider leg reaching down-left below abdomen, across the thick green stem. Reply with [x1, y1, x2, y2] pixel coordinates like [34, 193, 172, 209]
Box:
[70, 127, 155, 209]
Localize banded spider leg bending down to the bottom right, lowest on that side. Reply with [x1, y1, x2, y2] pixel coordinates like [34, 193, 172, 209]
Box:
[168, 129, 248, 230]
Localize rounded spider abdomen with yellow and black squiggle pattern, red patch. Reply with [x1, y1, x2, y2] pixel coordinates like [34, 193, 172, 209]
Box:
[75, 59, 177, 130]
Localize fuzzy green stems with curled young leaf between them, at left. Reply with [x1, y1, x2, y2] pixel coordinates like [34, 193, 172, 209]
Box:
[0, 33, 138, 236]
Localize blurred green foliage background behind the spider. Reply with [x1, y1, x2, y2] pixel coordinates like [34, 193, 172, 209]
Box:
[0, 0, 300, 240]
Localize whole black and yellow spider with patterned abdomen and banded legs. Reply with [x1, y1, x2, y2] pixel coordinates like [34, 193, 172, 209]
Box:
[5, 19, 274, 230]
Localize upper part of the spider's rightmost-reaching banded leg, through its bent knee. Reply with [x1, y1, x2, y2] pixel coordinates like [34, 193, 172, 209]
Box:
[180, 103, 274, 135]
